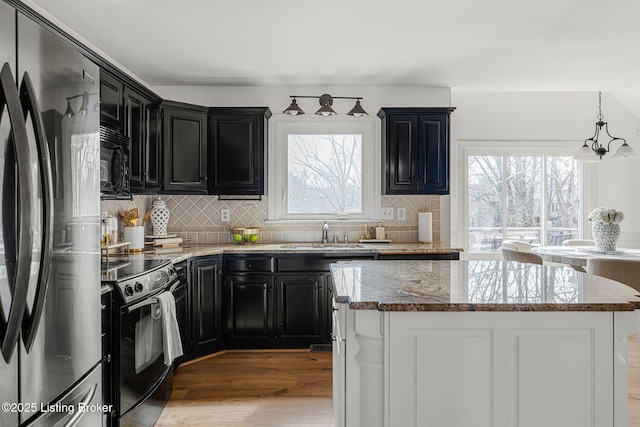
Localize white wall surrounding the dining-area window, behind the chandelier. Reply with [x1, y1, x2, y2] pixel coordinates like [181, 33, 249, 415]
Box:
[451, 90, 640, 247]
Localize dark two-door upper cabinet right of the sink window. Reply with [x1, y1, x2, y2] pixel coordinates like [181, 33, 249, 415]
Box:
[378, 107, 455, 194]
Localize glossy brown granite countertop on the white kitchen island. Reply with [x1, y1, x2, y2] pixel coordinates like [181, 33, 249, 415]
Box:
[331, 260, 640, 311]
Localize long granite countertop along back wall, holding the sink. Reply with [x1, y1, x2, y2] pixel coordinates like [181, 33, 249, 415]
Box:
[116, 242, 463, 263]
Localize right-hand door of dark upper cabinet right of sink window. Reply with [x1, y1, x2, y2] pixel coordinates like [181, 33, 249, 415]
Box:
[418, 114, 449, 194]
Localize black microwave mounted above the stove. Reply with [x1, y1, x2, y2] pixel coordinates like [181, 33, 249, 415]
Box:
[100, 125, 132, 200]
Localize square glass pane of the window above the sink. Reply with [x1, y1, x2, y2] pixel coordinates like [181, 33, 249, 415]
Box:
[287, 134, 362, 214]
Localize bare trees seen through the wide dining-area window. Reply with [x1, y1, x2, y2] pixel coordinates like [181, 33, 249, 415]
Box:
[468, 155, 581, 252]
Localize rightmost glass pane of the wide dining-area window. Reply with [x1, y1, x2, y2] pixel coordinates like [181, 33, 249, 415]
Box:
[546, 157, 581, 245]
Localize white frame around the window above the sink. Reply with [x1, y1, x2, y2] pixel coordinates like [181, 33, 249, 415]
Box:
[267, 114, 382, 222]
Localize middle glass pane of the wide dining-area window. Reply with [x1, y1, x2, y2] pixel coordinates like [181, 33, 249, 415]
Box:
[504, 156, 542, 243]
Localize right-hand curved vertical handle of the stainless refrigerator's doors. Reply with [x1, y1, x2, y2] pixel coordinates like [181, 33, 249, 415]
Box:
[20, 72, 53, 353]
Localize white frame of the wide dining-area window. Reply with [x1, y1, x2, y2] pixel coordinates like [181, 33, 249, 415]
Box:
[456, 140, 595, 259]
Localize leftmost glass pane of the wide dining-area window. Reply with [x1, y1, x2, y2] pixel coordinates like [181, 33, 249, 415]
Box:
[468, 156, 503, 252]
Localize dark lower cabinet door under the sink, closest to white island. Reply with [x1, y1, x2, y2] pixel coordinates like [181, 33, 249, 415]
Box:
[276, 273, 329, 347]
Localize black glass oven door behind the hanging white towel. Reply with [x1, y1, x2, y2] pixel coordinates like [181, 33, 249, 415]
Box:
[117, 288, 179, 426]
